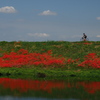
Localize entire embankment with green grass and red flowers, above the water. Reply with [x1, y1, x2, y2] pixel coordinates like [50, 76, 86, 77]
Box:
[0, 41, 100, 80]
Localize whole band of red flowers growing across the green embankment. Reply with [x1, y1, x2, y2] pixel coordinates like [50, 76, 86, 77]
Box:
[0, 49, 100, 68]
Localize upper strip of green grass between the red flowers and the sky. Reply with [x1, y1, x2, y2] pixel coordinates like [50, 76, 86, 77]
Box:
[0, 41, 100, 59]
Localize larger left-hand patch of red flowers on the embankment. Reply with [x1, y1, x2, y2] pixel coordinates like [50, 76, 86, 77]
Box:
[0, 49, 65, 67]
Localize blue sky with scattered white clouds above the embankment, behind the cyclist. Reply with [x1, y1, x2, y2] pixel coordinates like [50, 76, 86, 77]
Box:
[0, 0, 100, 41]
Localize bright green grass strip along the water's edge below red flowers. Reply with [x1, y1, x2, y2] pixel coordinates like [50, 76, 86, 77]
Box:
[0, 68, 100, 81]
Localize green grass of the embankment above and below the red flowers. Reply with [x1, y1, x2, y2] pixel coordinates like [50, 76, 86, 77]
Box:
[0, 41, 100, 78]
